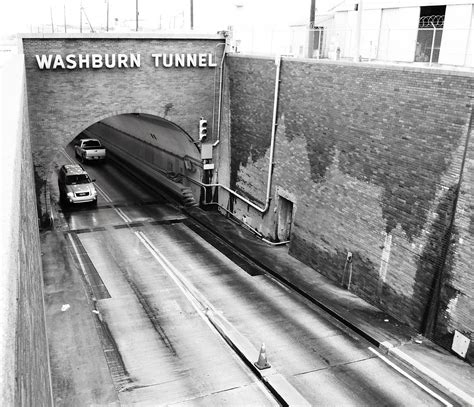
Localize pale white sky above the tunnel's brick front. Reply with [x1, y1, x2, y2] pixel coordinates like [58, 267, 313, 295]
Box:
[0, 0, 340, 38]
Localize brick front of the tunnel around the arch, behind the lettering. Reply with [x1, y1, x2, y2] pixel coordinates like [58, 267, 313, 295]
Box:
[23, 35, 223, 223]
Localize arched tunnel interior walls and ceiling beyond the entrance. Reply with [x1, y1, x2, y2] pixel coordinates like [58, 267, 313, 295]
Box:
[50, 113, 203, 212]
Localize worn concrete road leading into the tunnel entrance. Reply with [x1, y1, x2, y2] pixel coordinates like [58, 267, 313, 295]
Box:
[42, 148, 452, 406]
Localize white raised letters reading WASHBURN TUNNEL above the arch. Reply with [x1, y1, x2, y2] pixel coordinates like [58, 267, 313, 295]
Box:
[35, 54, 217, 69]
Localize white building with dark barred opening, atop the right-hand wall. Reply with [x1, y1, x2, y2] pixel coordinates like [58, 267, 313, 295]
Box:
[315, 0, 474, 67]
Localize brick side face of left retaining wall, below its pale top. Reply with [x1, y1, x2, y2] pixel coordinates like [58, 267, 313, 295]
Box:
[15, 90, 53, 406]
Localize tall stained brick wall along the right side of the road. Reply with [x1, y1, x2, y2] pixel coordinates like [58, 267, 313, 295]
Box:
[227, 56, 474, 356]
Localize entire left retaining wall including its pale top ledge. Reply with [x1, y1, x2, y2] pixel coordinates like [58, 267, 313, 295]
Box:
[0, 57, 52, 406]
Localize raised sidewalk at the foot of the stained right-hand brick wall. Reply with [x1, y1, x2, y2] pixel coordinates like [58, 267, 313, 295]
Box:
[184, 207, 474, 406]
